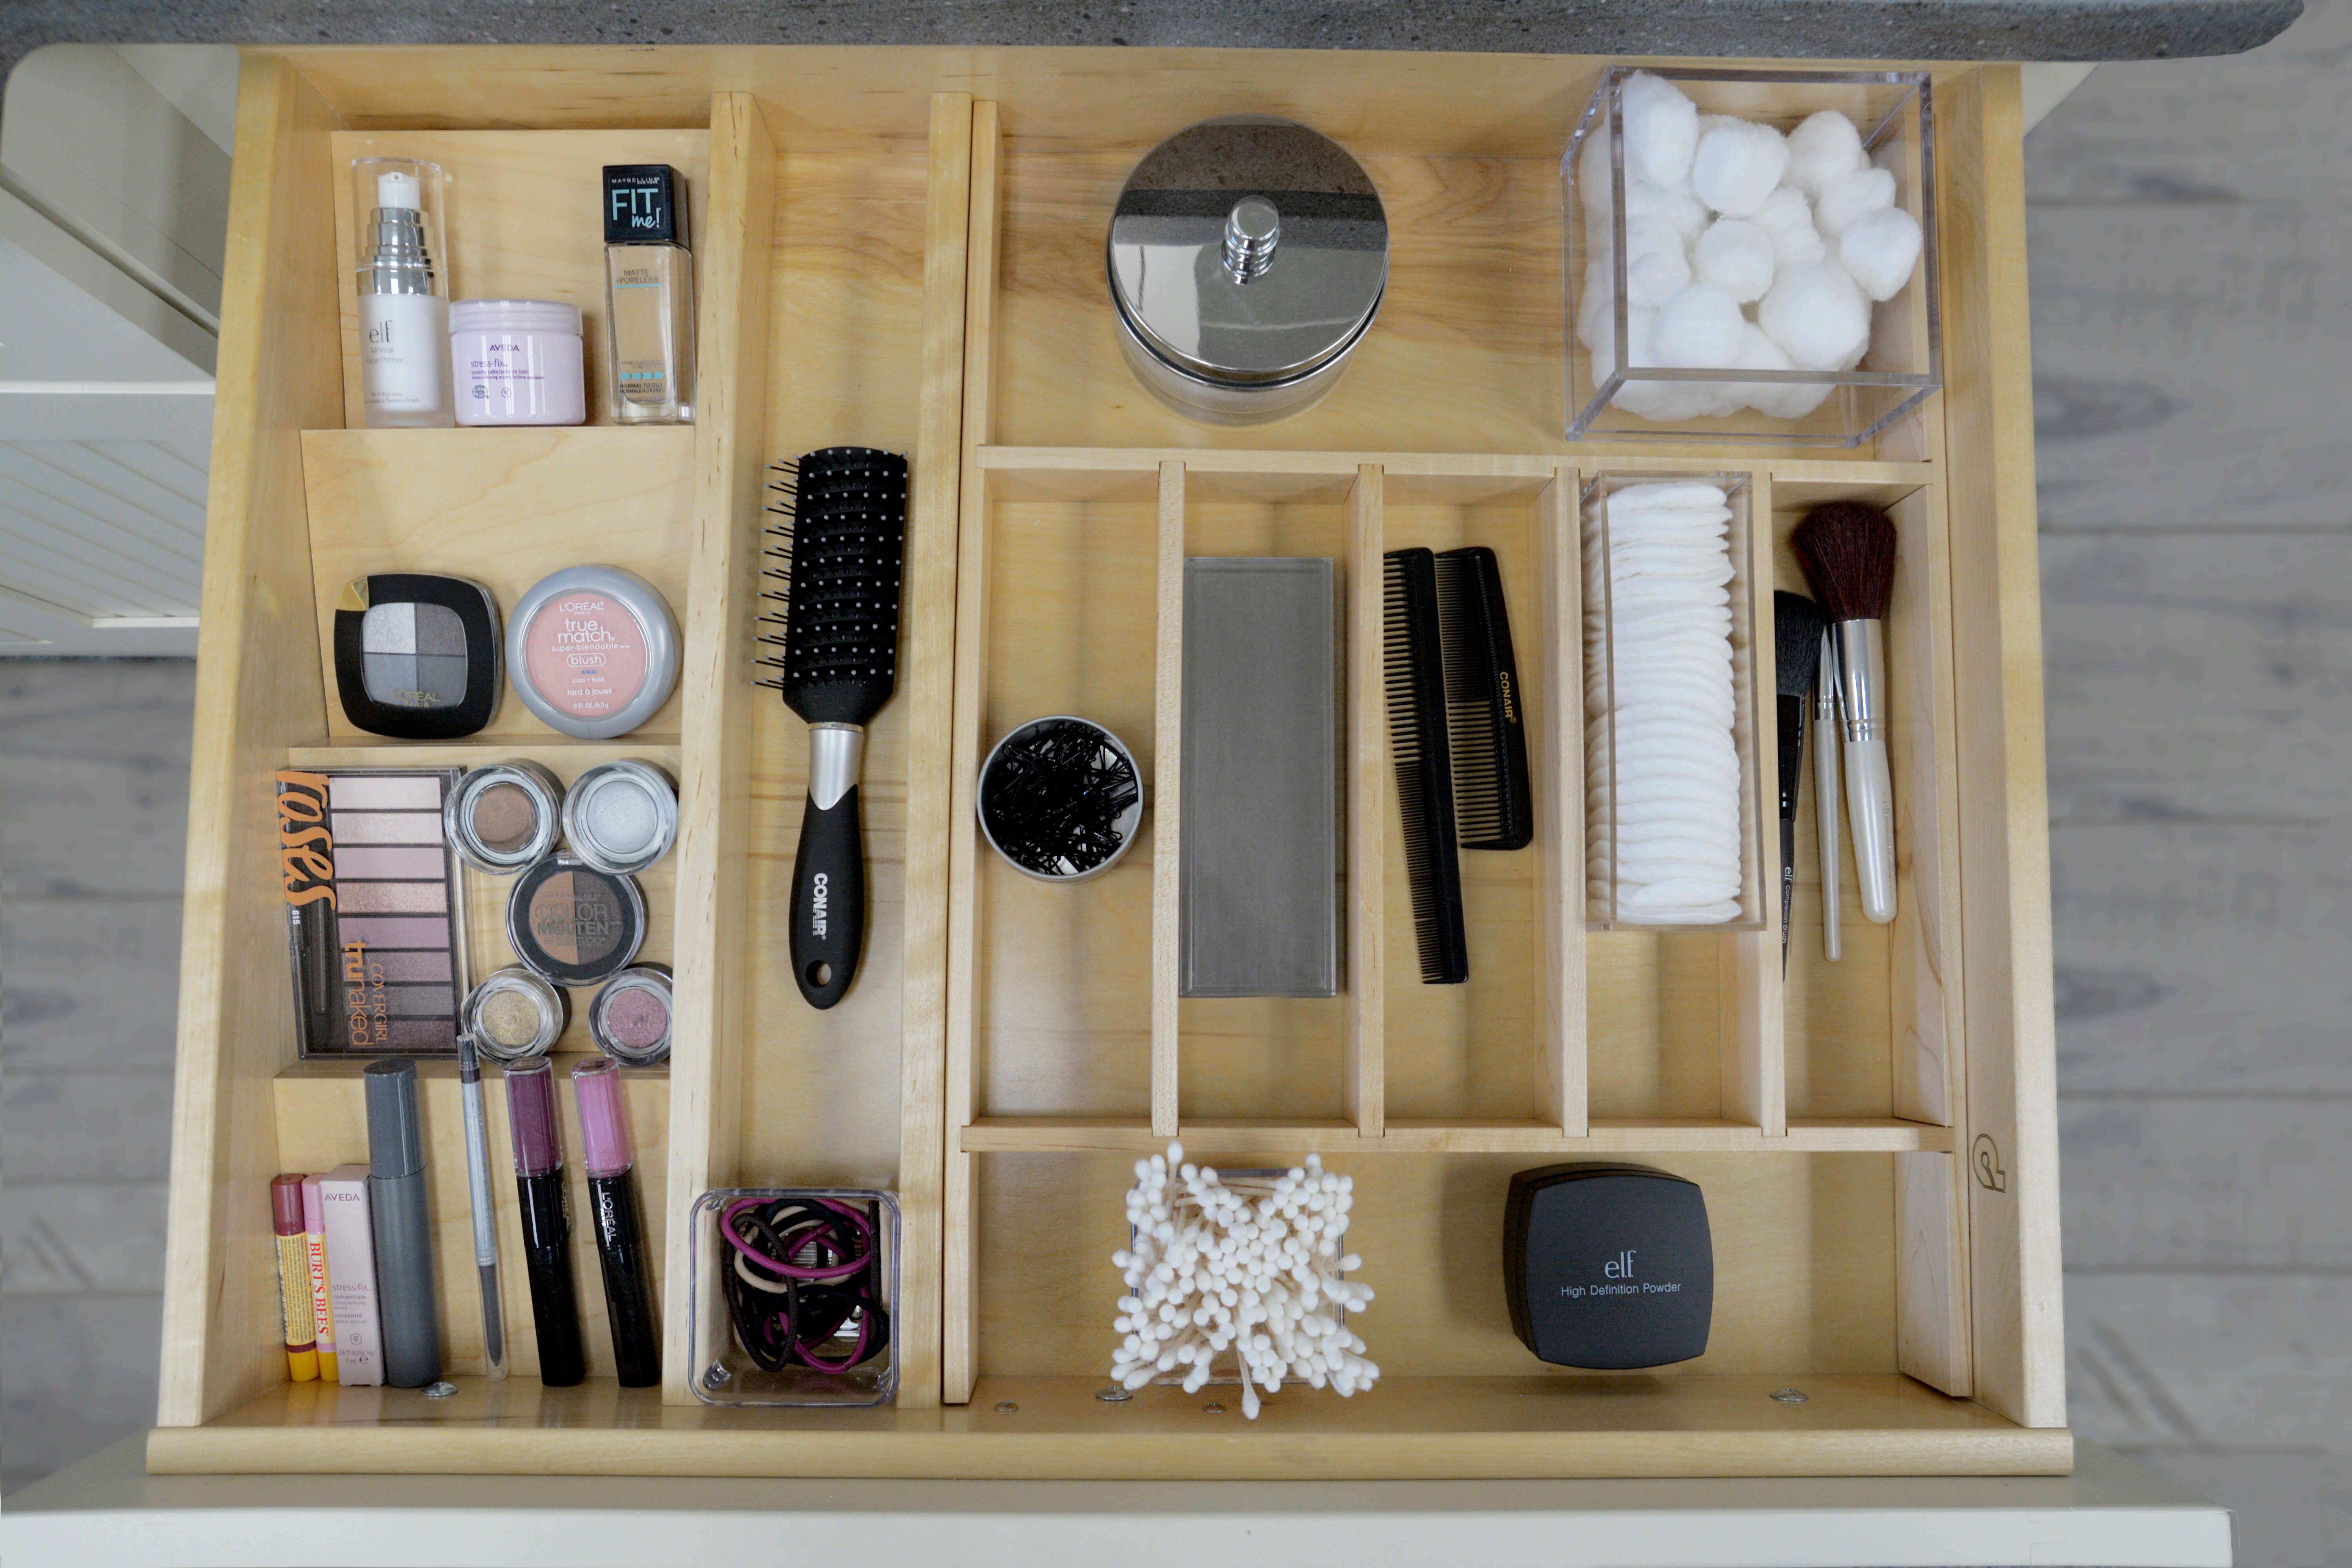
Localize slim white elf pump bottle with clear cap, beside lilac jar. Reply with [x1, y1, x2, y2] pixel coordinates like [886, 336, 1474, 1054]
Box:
[350, 158, 452, 428]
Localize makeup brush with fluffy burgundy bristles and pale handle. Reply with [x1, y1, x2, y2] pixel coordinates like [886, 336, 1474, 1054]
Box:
[1790, 501, 1896, 926]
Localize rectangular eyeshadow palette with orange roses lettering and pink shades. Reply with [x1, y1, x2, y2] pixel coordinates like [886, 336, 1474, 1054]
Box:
[278, 769, 468, 1056]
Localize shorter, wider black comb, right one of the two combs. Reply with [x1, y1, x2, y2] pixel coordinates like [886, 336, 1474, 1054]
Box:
[1437, 545, 1536, 849]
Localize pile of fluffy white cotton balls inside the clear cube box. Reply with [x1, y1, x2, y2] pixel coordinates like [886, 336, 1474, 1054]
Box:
[1576, 71, 1922, 421]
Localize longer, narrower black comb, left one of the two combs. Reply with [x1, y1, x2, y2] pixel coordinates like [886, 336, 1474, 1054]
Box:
[1381, 550, 1458, 985]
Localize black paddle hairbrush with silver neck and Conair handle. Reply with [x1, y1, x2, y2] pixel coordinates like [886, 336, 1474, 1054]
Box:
[760, 446, 906, 1009]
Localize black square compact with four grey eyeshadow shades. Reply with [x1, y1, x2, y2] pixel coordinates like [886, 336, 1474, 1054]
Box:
[334, 571, 499, 740]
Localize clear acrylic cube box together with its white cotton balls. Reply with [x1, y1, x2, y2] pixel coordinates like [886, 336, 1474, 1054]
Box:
[1559, 66, 1943, 446]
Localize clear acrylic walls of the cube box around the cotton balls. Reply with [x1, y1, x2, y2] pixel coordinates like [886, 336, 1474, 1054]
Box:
[1559, 66, 1943, 446]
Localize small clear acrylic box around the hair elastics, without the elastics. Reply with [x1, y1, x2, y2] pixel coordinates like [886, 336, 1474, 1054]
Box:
[687, 1187, 898, 1408]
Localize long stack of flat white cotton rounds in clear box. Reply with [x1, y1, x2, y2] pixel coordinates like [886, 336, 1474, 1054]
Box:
[1585, 482, 1740, 926]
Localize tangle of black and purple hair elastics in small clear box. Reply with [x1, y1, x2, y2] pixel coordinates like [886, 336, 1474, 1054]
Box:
[720, 1196, 889, 1373]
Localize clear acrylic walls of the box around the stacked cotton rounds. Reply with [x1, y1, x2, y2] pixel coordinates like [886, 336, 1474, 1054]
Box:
[1578, 470, 1778, 931]
